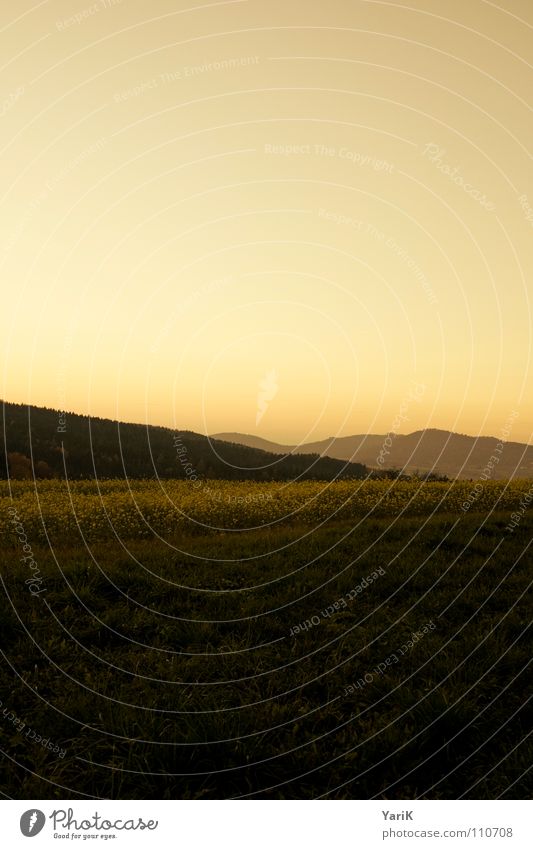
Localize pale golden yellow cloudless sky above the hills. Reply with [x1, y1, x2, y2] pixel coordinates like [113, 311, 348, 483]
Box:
[0, 0, 533, 444]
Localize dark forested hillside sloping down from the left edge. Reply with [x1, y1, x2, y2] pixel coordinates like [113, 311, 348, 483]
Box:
[0, 401, 368, 481]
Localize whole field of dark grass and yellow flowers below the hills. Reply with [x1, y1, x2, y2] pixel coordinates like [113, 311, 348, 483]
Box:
[0, 480, 533, 799]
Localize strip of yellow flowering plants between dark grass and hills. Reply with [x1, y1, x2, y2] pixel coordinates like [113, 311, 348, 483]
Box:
[0, 480, 533, 541]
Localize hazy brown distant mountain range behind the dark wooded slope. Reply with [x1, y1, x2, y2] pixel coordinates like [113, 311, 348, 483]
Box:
[213, 429, 533, 479]
